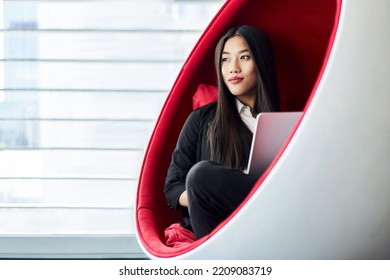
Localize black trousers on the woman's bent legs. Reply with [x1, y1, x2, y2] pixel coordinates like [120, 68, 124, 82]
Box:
[186, 161, 258, 239]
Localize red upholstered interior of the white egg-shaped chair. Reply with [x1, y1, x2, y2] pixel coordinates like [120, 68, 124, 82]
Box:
[136, 0, 341, 258]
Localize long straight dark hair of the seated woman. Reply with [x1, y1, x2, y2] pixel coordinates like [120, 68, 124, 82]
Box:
[208, 25, 279, 169]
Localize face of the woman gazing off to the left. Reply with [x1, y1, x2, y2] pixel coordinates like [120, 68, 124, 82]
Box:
[221, 36, 257, 108]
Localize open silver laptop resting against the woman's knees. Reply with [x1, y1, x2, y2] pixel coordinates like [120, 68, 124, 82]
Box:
[246, 112, 302, 177]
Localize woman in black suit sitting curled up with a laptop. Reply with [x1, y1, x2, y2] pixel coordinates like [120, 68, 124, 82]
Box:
[164, 26, 279, 239]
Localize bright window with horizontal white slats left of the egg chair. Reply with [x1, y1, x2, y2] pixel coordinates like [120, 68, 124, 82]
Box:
[0, 0, 223, 258]
